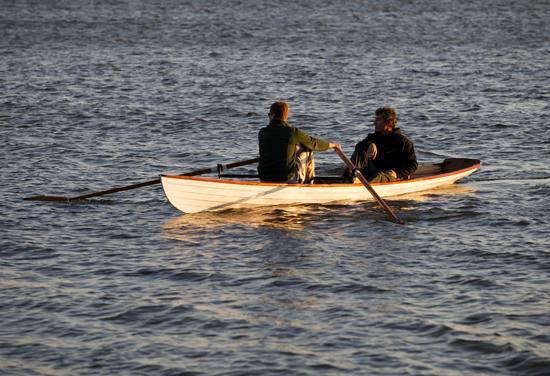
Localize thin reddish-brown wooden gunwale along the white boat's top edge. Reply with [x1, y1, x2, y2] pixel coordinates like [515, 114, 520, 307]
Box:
[160, 160, 481, 188]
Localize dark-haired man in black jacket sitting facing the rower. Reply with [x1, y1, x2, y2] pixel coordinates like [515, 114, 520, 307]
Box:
[344, 107, 418, 183]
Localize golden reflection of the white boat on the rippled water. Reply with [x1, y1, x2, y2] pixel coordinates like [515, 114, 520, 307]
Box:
[162, 184, 475, 240]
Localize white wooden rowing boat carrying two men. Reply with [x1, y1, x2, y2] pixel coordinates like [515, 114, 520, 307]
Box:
[161, 158, 481, 213]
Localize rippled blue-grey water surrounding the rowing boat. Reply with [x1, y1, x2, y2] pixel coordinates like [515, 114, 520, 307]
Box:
[0, 0, 550, 375]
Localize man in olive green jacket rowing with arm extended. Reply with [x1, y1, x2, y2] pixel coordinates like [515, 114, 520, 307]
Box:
[258, 101, 341, 183]
